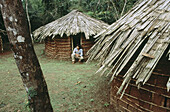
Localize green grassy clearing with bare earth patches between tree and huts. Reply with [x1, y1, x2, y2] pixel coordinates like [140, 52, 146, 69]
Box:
[0, 44, 114, 112]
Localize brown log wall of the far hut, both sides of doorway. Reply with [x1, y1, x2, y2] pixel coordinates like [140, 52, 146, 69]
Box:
[45, 36, 94, 60]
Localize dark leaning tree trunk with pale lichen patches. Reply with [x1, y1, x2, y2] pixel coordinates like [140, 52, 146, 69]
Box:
[0, 0, 53, 112]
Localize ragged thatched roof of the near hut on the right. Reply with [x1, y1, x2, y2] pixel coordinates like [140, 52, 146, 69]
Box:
[88, 0, 170, 96]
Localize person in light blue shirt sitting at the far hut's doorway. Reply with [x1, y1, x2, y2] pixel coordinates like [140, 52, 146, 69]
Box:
[71, 45, 84, 64]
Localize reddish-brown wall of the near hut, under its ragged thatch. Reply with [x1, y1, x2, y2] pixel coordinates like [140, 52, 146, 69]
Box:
[110, 57, 170, 112]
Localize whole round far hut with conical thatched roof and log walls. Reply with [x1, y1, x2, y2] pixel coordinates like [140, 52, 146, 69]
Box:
[33, 10, 108, 59]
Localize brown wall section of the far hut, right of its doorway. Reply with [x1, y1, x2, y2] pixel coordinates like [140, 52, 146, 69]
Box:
[81, 35, 94, 58]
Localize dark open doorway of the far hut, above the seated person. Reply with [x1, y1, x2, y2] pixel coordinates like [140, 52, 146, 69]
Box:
[71, 34, 81, 50]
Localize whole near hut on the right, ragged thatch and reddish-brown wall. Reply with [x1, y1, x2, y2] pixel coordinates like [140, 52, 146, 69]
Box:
[88, 0, 170, 112]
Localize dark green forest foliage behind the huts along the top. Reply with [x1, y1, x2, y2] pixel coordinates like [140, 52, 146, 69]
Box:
[0, 0, 137, 31]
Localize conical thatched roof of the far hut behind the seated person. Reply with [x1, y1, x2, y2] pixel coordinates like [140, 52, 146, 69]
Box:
[33, 10, 108, 40]
